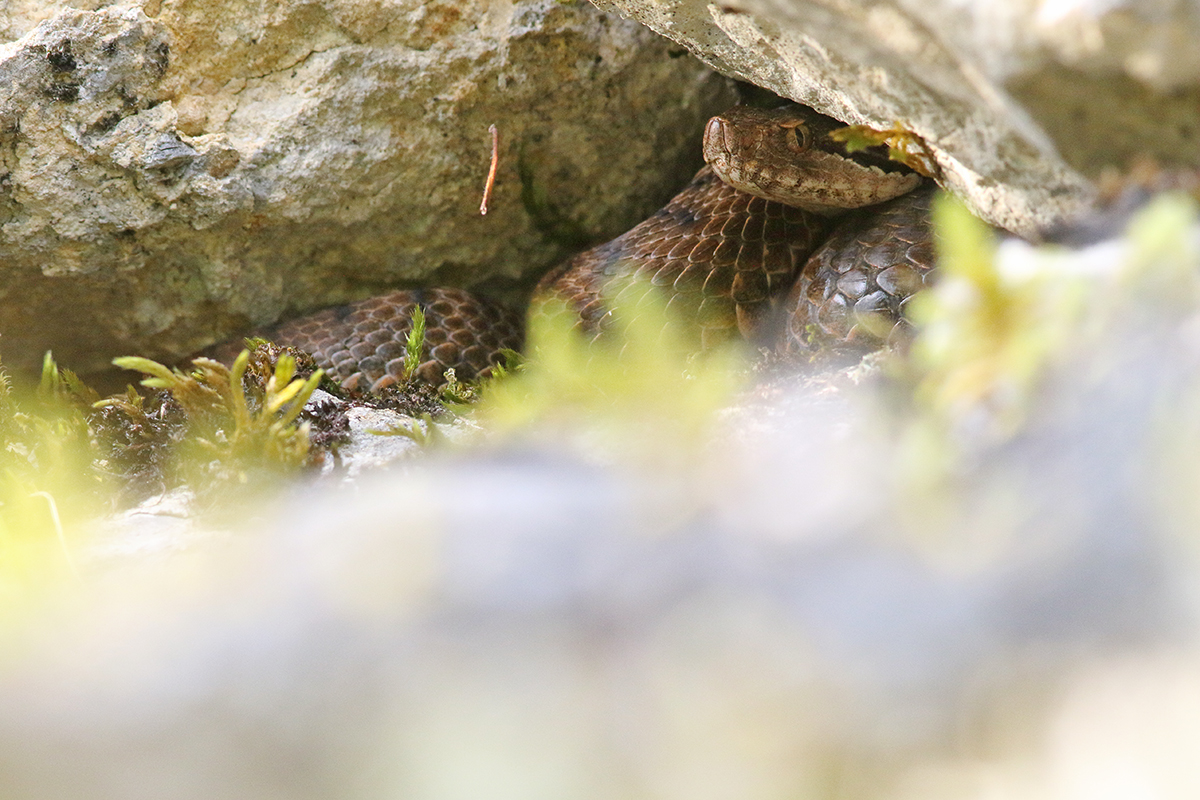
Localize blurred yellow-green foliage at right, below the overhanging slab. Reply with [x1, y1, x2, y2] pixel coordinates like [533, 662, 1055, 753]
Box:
[893, 193, 1200, 443]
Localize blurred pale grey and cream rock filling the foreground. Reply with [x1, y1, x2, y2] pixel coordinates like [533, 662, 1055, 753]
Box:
[0, 227, 1200, 800]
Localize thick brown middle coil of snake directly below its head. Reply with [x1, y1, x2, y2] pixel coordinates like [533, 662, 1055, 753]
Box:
[536, 167, 828, 347]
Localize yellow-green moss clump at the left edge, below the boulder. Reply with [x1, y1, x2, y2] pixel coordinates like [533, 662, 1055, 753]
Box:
[0, 350, 322, 620]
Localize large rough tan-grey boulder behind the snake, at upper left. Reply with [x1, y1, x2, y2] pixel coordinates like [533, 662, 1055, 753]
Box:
[0, 0, 732, 372]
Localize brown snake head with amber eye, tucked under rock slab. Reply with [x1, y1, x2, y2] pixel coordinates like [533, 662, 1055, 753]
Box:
[704, 106, 922, 215]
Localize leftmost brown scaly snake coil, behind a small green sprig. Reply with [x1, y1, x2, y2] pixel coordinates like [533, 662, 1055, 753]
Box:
[226, 289, 523, 391]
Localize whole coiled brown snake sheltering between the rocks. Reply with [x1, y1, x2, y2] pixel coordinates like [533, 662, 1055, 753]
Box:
[211, 106, 934, 390]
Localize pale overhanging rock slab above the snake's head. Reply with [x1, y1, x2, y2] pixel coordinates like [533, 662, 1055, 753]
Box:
[596, 0, 1200, 235]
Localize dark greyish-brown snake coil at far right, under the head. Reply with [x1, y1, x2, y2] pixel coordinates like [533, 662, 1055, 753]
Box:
[779, 187, 935, 353]
